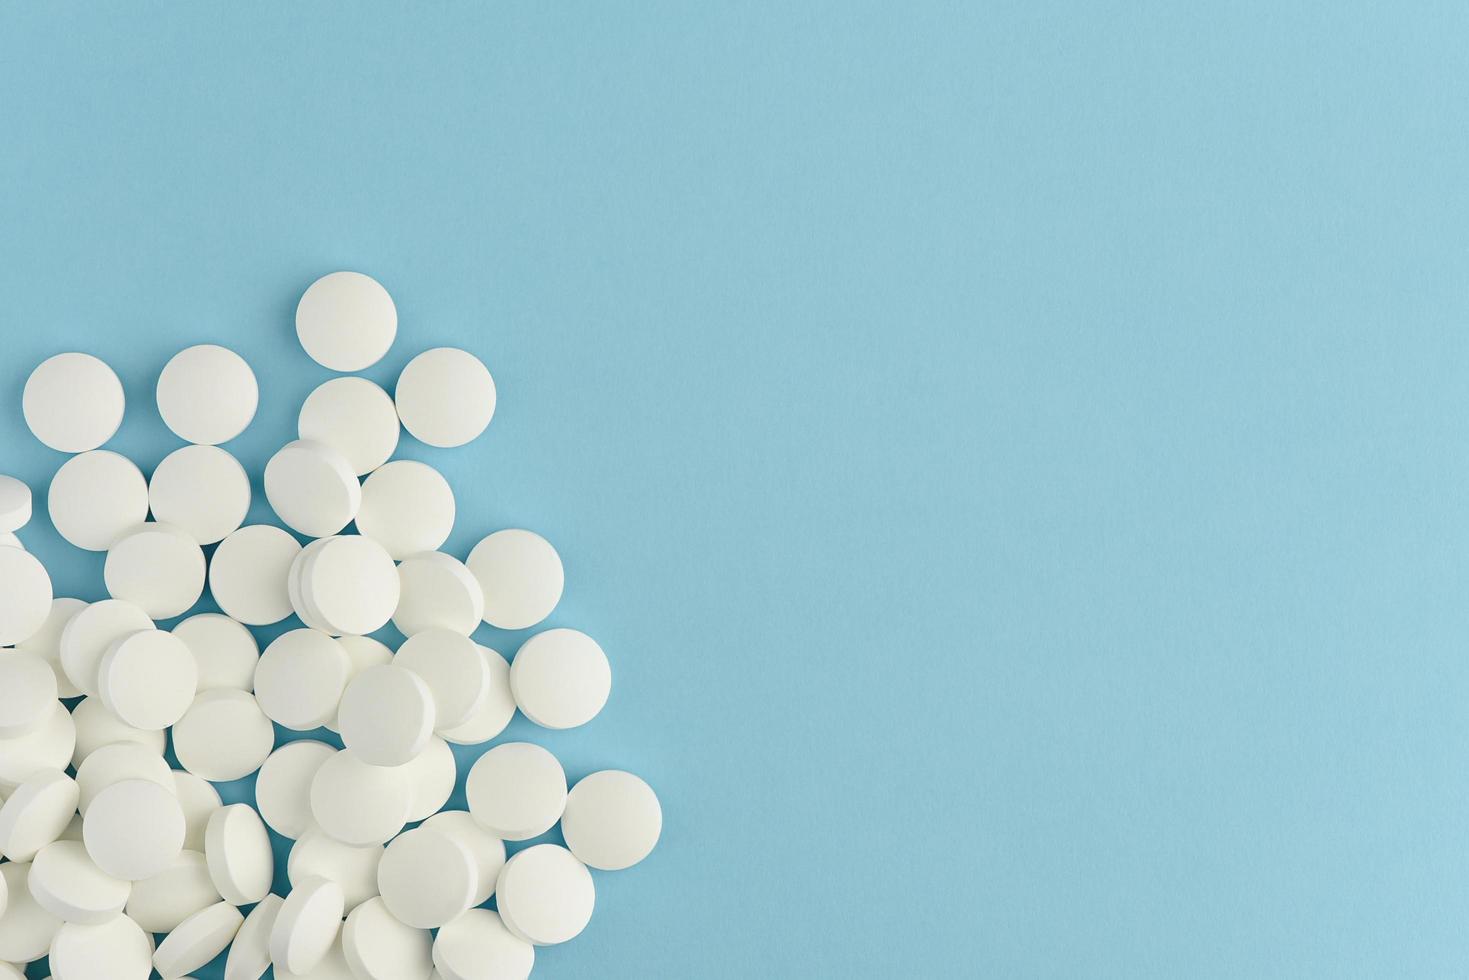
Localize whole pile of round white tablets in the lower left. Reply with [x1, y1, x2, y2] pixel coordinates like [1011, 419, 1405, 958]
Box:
[0, 272, 663, 980]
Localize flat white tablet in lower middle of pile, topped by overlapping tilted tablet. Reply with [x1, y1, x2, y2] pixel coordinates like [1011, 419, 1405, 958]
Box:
[311, 751, 413, 848]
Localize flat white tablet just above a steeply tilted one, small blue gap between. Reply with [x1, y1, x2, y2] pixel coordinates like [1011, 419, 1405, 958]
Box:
[173, 688, 275, 783]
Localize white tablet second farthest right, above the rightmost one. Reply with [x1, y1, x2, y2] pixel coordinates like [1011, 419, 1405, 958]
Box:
[510, 629, 613, 729]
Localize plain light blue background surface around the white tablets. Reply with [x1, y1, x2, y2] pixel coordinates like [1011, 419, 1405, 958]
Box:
[0, 0, 1469, 977]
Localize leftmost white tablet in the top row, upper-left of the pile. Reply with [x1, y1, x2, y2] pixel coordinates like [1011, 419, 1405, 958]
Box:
[21, 353, 125, 453]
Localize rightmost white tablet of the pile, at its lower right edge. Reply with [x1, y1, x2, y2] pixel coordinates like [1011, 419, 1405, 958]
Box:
[561, 768, 663, 871]
